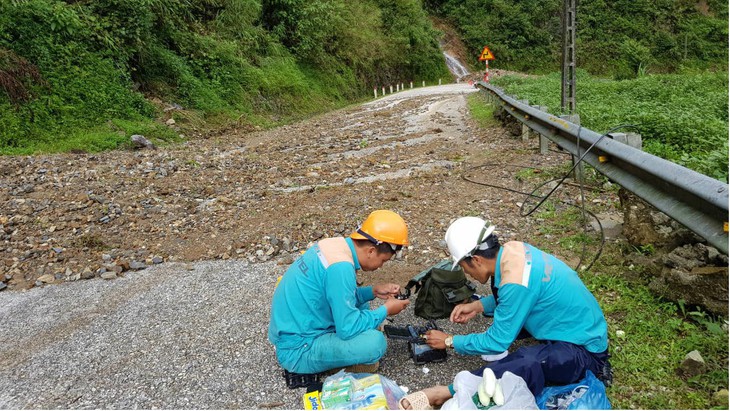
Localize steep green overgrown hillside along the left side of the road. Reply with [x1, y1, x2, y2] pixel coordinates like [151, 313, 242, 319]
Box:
[0, 0, 449, 153]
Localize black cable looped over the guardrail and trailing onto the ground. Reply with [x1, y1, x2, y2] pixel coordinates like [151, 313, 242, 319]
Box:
[461, 124, 637, 271]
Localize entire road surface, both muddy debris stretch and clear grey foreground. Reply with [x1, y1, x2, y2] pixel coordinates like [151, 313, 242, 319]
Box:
[0, 84, 616, 409]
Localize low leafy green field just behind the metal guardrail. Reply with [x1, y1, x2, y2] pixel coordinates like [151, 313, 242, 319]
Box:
[494, 71, 728, 181]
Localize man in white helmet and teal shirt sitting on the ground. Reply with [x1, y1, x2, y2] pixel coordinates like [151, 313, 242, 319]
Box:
[401, 217, 611, 409]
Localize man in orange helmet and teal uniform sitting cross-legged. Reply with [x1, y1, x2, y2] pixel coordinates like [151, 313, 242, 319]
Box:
[269, 210, 409, 374]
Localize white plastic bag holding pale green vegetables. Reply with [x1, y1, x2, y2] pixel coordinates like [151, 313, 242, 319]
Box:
[441, 371, 537, 411]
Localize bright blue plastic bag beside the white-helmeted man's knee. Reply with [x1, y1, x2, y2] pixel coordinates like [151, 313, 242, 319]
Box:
[537, 371, 611, 410]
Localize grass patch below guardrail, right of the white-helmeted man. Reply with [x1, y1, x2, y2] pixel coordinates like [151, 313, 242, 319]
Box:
[581, 248, 728, 410]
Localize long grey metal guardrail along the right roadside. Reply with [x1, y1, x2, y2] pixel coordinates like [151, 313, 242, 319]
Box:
[476, 82, 728, 254]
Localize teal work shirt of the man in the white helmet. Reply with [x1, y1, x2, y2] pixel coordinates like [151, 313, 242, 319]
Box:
[454, 243, 608, 355]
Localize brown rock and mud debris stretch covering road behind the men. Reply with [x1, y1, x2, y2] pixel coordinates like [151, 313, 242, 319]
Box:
[0, 84, 584, 290]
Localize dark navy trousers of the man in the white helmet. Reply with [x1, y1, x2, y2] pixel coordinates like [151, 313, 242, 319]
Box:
[471, 341, 608, 397]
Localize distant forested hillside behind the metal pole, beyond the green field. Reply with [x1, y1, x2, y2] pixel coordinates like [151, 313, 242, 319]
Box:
[426, 0, 728, 78]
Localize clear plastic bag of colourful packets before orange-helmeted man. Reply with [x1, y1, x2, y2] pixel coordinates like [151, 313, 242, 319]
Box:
[320, 370, 405, 410]
